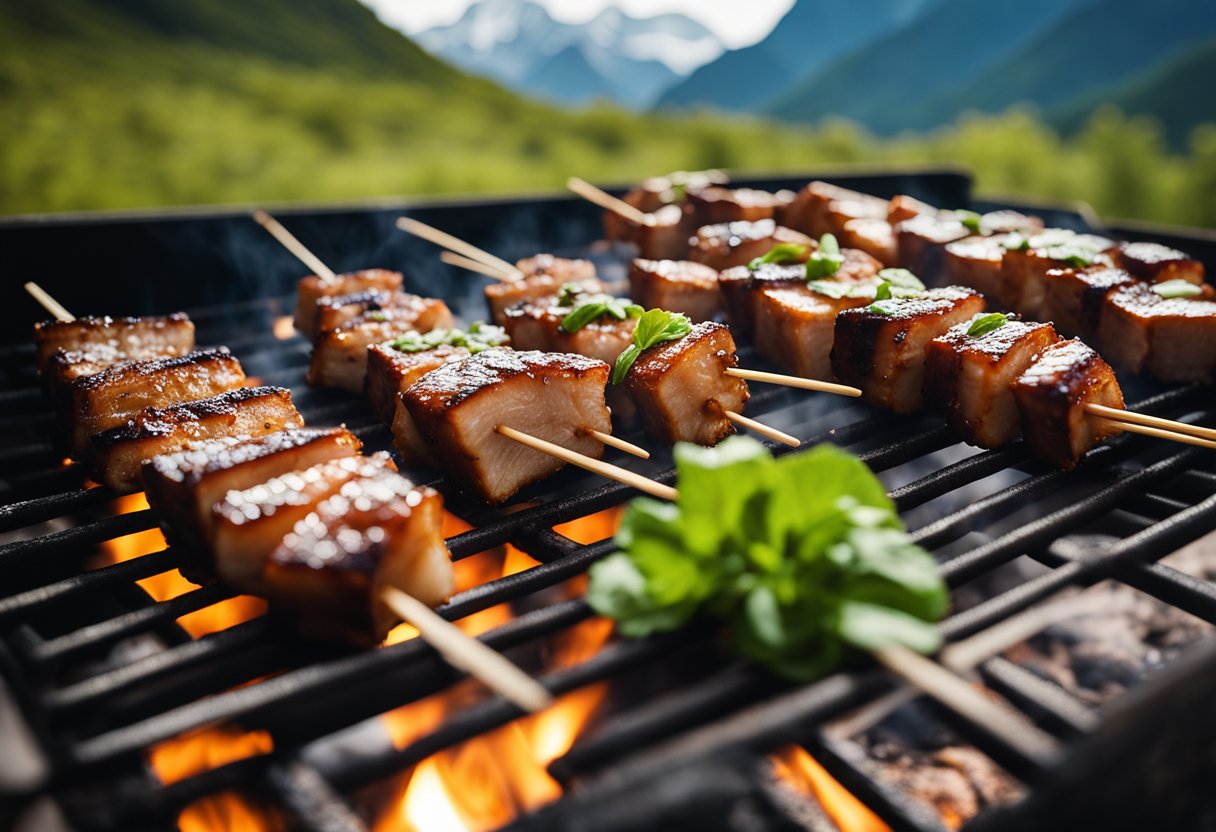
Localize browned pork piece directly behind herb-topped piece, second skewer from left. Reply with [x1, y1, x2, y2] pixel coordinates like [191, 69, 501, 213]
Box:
[308, 294, 452, 393]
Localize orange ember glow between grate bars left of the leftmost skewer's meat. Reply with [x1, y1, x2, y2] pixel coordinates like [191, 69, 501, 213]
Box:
[101, 493, 266, 639]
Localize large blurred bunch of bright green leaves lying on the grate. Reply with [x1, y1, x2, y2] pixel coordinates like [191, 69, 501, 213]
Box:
[587, 437, 948, 680]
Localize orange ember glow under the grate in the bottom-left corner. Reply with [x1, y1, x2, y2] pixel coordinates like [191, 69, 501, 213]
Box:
[148, 729, 275, 832]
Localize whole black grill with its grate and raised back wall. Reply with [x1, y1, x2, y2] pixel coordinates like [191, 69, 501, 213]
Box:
[0, 170, 1216, 831]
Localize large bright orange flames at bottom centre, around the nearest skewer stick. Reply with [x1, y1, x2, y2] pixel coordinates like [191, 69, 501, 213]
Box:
[373, 510, 620, 832]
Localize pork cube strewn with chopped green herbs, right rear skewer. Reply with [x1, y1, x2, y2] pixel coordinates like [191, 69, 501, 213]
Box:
[998, 229, 1115, 317]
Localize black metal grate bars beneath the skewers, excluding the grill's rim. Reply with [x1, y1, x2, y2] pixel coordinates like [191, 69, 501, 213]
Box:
[0, 173, 1216, 830]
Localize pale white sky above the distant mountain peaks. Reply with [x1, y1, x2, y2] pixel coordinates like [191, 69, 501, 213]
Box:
[362, 0, 794, 49]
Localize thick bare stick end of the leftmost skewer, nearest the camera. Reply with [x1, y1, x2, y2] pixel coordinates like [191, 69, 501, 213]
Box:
[381, 586, 553, 713]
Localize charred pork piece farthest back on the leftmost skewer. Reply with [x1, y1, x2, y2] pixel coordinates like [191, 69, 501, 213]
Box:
[34, 313, 195, 371]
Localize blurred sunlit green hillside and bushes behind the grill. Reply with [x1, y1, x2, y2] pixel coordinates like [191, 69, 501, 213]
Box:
[0, 0, 1216, 226]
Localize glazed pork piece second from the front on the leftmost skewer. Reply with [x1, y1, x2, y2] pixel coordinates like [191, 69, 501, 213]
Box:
[208, 451, 396, 595]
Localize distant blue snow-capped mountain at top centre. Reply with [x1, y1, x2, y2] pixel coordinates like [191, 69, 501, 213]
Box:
[415, 0, 724, 108]
